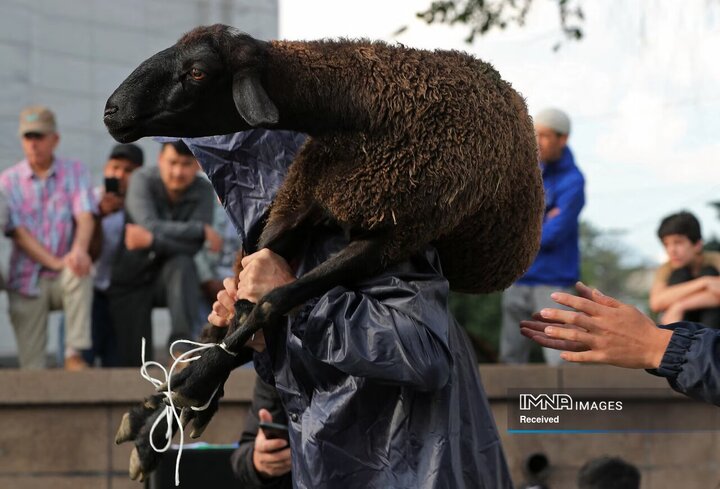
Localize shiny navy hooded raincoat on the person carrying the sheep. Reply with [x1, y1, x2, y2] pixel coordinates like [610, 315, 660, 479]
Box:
[186, 131, 512, 489]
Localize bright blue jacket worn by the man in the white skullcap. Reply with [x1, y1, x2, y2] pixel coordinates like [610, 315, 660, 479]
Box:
[517, 146, 585, 287]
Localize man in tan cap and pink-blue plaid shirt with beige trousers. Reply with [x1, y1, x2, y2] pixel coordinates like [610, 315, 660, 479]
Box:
[0, 106, 95, 370]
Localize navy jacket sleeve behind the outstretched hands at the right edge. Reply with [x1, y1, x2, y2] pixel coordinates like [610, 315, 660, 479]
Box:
[651, 322, 720, 406]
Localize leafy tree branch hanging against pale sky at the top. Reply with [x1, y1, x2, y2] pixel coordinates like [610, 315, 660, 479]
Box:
[408, 0, 584, 49]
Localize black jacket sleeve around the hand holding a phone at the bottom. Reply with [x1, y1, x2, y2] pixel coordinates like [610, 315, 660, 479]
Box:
[230, 378, 290, 489]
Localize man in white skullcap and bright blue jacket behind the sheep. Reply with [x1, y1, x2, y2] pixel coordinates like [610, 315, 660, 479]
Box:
[500, 109, 585, 365]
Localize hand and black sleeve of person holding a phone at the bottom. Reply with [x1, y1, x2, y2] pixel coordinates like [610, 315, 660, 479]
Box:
[235, 377, 292, 489]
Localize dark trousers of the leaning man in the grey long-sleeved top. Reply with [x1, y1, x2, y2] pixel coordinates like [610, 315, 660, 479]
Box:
[109, 255, 200, 367]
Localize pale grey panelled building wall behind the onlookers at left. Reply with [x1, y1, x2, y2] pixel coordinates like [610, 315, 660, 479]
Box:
[0, 0, 278, 357]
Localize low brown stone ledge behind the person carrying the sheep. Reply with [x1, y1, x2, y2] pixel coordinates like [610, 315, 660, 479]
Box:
[0, 365, 720, 489]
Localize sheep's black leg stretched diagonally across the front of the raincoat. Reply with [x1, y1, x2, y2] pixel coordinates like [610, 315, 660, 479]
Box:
[167, 236, 387, 406]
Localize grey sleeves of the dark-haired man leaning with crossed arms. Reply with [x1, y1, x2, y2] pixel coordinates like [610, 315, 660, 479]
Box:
[125, 172, 213, 255]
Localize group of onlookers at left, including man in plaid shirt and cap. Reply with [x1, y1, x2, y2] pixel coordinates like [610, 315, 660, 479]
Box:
[0, 106, 240, 370]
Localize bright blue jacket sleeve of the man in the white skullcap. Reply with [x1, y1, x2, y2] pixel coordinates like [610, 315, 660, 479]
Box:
[540, 175, 585, 249]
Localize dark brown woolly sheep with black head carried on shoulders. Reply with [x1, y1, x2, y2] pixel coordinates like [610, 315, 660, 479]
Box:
[104, 25, 543, 478]
